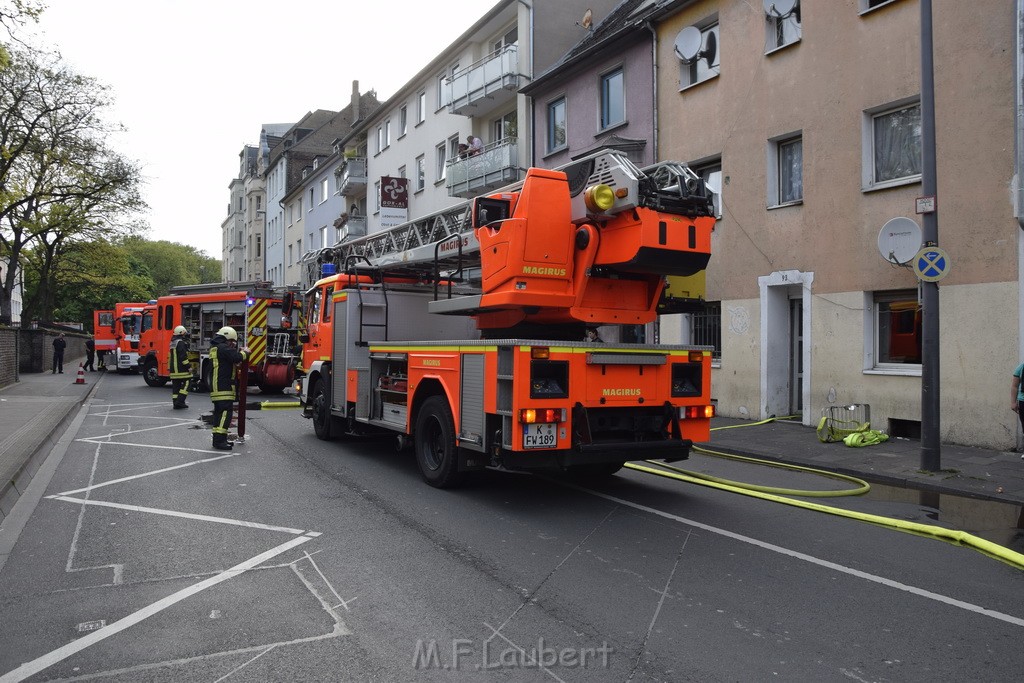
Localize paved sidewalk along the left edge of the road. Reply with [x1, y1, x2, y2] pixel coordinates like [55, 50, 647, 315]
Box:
[0, 359, 95, 523]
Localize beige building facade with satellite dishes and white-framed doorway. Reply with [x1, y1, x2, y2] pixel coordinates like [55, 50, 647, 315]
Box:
[655, 0, 1021, 450]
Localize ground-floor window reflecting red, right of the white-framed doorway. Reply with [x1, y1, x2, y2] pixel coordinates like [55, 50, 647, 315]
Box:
[865, 290, 921, 370]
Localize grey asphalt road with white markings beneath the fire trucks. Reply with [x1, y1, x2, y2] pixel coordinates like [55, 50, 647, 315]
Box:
[0, 376, 1024, 682]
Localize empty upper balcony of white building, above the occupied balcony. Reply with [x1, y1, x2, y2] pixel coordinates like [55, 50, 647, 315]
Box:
[444, 45, 519, 116]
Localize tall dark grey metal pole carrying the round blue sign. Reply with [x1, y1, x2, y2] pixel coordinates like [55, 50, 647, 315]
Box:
[921, 0, 942, 472]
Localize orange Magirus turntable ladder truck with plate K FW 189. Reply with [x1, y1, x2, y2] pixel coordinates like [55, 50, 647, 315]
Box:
[299, 152, 715, 487]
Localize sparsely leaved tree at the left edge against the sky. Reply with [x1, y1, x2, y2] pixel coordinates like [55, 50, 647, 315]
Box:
[0, 50, 145, 323]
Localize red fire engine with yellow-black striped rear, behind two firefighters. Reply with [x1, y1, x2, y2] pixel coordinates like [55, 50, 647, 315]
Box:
[138, 283, 299, 393]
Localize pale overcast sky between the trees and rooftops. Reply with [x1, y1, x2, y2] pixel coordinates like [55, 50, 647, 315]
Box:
[27, 0, 497, 259]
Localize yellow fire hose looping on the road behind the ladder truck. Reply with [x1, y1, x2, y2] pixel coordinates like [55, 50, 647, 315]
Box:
[626, 418, 1024, 569]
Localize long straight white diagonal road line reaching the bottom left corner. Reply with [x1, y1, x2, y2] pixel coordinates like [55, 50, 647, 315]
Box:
[0, 536, 311, 683]
